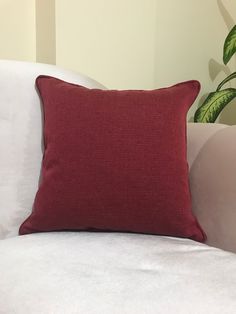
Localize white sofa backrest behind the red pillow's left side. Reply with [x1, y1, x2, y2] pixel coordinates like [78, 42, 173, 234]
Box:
[0, 60, 105, 239]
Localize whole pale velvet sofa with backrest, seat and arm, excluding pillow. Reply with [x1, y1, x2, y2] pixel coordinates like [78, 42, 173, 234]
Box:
[0, 60, 236, 314]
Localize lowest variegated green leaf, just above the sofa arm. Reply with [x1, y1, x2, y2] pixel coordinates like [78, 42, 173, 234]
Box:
[194, 88, 236, 123]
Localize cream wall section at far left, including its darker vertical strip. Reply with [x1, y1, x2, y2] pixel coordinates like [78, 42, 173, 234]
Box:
[0, 0, 56, 63]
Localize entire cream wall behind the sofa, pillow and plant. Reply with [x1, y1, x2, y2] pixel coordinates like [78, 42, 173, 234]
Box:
[0, 0, 236, 124]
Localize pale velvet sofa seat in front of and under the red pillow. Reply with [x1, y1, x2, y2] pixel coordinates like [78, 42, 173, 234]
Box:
[0, 232, 236, 314]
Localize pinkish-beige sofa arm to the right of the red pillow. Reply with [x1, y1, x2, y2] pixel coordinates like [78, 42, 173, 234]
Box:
[188, 123, 236, 252]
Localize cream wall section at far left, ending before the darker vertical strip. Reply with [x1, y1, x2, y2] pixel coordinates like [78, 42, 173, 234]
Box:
[0, 0, 36, 61]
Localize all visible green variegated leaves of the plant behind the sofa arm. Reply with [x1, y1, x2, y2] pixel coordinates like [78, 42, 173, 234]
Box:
[194, 25, 236, 123]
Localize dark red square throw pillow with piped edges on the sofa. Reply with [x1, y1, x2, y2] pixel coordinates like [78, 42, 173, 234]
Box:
[19, 76, 205, 241]
